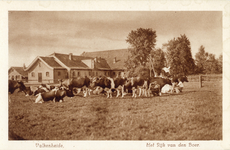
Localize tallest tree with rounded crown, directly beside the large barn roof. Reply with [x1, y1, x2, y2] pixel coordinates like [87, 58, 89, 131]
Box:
[125, 28, 157, 77]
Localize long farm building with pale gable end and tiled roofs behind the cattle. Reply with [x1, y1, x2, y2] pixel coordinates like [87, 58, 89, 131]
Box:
[22, 50, 127, 83]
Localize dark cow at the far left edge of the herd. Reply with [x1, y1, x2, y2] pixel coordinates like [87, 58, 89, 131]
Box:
[8, 80, 26, 94]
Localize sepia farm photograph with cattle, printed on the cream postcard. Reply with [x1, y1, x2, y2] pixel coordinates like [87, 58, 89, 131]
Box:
[0, 0, 229, 149]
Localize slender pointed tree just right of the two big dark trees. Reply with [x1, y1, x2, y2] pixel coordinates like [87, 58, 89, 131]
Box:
[195, 45, 209, 73]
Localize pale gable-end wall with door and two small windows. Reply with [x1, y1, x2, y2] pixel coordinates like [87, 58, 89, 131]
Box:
[28, 60, 53, 83]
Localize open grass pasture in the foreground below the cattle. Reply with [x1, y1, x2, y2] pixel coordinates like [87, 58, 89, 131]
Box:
[9, 81, 222, 140]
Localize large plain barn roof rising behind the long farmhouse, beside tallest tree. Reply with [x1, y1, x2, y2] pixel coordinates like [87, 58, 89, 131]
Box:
[81, 49, 130, 70]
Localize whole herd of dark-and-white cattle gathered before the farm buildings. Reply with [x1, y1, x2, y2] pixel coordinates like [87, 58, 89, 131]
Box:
[9, 76, 188, 103]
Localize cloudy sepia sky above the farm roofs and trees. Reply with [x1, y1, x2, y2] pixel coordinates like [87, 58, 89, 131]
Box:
[8, 11, 222, 67]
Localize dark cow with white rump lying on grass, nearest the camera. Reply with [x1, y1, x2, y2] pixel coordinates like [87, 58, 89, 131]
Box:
[35, 89, 66, 103]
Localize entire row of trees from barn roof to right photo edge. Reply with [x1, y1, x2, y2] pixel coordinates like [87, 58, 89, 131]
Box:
[126, 28, 222, 76]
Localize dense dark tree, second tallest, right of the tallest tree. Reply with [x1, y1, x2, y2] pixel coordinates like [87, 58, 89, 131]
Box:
[164, 35, 195, 75]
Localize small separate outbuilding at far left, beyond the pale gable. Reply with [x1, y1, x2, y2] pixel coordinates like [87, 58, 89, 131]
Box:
[8, 67, 28, 82]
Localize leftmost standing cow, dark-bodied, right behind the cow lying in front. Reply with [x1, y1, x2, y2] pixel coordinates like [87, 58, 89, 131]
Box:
[61, 76, 91, 97]
